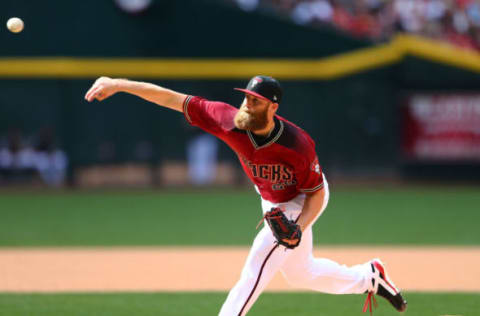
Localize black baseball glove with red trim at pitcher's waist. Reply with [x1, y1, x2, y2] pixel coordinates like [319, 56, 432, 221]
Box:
[264, 207, 302, 249]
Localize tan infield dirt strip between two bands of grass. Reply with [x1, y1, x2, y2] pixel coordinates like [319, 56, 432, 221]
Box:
[0, 247, 480, 292]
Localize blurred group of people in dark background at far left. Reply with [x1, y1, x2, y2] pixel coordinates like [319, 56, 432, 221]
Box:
[0, 128, 68, 186]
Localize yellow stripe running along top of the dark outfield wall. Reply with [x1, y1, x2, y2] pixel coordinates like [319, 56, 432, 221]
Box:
[0, 35, 480, 80]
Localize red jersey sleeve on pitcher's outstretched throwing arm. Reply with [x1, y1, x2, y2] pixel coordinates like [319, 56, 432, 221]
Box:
[183, 96, 237, 135]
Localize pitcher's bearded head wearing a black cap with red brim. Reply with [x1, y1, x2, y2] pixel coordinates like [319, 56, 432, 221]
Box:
[234, 76, 282, 131]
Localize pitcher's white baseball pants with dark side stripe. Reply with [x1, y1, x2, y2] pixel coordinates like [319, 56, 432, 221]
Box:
[219, 179, 372, 316]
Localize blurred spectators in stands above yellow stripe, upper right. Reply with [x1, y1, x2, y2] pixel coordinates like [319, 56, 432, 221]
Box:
[233, 0, 480, 50]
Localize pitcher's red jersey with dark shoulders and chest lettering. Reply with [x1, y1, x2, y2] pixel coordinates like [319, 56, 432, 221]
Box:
[183, 96, 323, 203]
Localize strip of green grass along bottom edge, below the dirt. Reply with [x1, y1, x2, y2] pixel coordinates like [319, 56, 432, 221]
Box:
[0, 293, 480, 316]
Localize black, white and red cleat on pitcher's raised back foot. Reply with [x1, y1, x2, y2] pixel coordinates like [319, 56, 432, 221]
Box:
[363, 259, 407, 314]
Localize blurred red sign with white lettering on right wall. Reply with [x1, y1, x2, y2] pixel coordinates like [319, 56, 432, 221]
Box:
[403, 94, 480, 161]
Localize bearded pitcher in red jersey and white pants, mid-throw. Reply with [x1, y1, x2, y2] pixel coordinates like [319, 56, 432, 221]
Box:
[85, 76, 407, 316]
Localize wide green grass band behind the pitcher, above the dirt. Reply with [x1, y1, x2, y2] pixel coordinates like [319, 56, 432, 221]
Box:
[0, 187, 480, 246]
